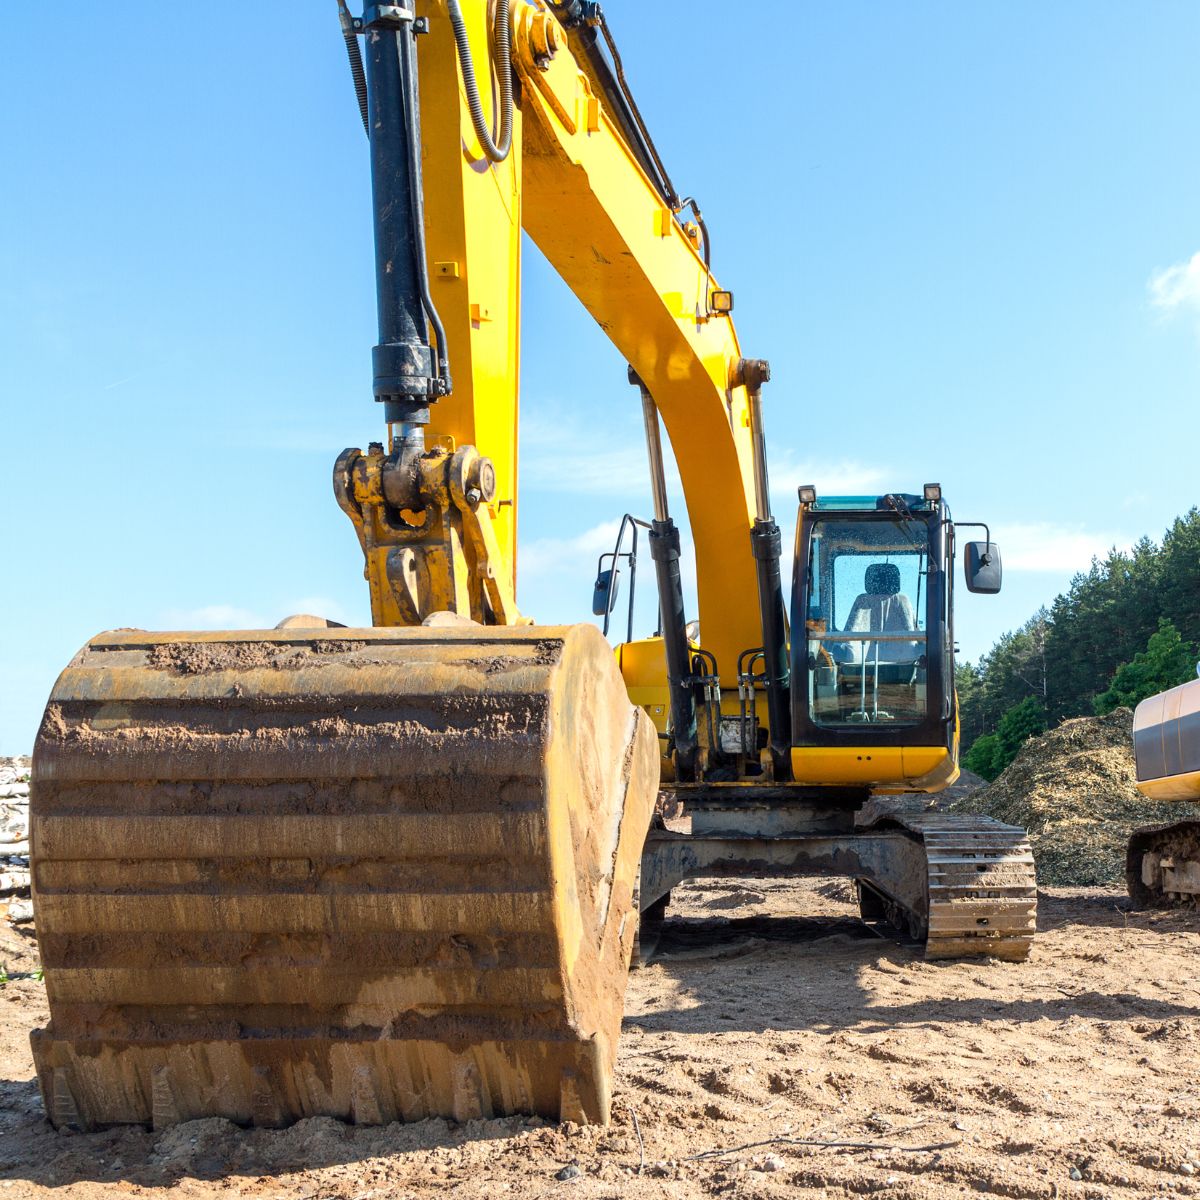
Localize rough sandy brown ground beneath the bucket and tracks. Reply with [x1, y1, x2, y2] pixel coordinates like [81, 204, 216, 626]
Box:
[0, 881, 1200, 1200]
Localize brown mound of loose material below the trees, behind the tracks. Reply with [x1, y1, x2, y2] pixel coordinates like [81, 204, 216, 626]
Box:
[954, 708, 1200, 887]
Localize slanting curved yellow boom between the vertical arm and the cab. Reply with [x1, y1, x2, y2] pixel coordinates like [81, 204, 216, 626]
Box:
[514, 5, 762, 686]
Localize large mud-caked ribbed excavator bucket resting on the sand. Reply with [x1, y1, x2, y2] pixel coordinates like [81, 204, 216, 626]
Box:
[31, 625, 659, 1128]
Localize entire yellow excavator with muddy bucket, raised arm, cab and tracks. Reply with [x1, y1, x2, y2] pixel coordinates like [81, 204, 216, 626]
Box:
[31, 0, 1036, 1128]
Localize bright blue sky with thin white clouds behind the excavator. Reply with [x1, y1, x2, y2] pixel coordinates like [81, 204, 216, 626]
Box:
[0, 0, 1200, 754]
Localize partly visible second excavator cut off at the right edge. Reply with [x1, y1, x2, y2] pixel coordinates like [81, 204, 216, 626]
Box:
[1126, 666, 1200, 906]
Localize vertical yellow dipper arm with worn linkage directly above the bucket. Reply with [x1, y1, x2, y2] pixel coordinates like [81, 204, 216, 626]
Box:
[335, 0, 524, 626]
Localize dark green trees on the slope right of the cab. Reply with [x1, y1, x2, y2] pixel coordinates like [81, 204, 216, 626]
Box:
[958, 509, 1200, 779]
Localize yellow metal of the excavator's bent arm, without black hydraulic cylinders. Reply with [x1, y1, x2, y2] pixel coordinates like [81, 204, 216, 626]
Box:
[336, 0, 761, 666]
